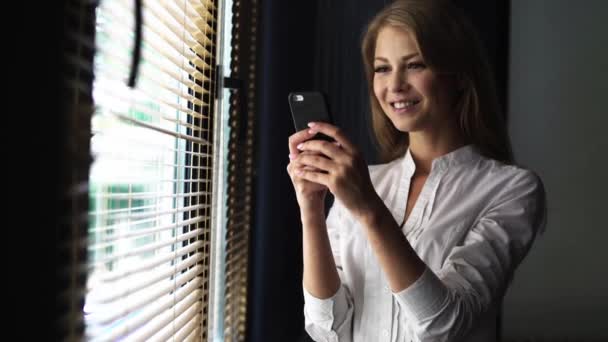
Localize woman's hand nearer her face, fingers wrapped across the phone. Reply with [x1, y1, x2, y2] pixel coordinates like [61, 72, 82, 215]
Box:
[295, 122, 380, 218]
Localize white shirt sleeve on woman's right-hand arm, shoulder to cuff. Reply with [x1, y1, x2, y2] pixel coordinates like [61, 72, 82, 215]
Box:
[394, 171, 546, 341]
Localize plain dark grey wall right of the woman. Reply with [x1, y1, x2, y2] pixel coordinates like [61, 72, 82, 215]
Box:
[504, 0, 608, 342]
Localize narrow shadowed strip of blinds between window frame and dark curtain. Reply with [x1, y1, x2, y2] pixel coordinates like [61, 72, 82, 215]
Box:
[223, 0, 258, 341]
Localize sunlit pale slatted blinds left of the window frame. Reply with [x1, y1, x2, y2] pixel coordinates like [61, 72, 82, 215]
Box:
[84, 0, 218, 341]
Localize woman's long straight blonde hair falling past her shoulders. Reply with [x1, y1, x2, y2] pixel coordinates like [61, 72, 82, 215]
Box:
[361, 0, 513, 163]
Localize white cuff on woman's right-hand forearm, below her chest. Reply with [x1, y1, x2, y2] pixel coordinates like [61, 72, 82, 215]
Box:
[394, 267, 449, 322]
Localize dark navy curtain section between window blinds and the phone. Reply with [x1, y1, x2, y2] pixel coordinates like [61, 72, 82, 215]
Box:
[247, 0, 316, 342]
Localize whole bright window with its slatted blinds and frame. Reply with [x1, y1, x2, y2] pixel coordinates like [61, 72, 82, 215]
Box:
[53, 0, 257, 340]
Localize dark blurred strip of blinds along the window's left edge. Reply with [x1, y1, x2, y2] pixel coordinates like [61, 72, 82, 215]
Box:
[58, 0, 95, 341]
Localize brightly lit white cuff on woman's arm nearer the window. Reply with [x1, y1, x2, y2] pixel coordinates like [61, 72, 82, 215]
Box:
[303, 285, 348, 330]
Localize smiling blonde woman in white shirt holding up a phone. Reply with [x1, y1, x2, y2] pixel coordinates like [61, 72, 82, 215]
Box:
[287, 0, 545, 342]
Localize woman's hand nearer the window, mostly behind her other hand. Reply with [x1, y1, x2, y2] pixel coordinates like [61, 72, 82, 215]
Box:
[287, 129, 327, 217]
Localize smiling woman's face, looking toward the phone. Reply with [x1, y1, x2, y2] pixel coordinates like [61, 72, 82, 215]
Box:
[373, 26, 455, 133]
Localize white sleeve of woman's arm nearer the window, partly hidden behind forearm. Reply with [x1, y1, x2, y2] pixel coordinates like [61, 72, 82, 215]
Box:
[303, 200, 353, 342]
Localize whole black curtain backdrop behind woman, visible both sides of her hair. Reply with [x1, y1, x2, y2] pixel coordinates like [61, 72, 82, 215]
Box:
[247, 0, 509, 342]
